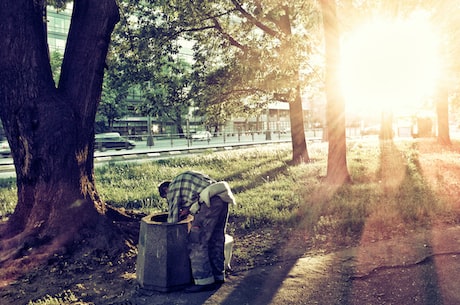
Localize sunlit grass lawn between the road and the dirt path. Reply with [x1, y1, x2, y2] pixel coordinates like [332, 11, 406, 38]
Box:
[4, 140, 460, 304]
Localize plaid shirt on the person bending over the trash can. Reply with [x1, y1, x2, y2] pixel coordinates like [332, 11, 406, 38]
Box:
[166, 171, 216, 223]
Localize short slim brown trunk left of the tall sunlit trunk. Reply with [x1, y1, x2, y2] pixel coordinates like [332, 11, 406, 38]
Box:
[289, 86, 310, 164]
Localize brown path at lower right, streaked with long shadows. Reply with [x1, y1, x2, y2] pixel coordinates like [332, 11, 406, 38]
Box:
[120, 222, 460, 305]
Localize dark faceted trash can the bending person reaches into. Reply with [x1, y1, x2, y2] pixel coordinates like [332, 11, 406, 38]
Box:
[136, 213, 193, 292]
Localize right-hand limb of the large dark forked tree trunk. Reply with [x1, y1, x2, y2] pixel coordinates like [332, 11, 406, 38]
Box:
[59, 0, 119, 126]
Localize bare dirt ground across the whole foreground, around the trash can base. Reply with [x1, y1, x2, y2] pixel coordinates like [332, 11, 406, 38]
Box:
[4, 222, 460, 305]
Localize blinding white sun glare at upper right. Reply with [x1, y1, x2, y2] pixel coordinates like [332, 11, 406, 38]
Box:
[340, 14, 440, 112]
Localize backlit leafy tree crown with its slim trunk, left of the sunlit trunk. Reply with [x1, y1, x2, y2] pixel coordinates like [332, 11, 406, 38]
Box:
[111, 1, 326, 162]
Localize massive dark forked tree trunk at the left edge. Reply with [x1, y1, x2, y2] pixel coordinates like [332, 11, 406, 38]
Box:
[0, 0, 118, 272]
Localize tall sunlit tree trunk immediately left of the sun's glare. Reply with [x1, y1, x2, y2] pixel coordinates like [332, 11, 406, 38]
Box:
[320, 0, 351, 185]
